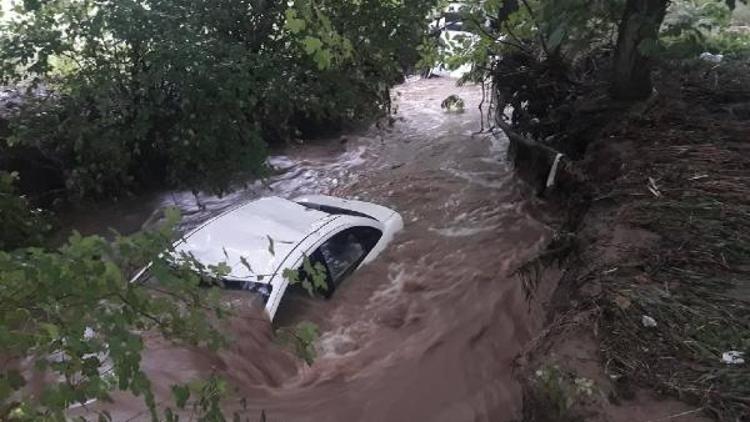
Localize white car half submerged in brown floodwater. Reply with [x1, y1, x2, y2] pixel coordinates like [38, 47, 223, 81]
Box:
[167, 195, 403, 320]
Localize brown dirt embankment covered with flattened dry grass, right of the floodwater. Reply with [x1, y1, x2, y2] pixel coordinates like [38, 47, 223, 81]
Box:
[517, 63, 750, 421]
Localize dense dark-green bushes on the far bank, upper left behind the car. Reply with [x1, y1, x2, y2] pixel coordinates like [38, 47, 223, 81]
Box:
[0, 0, 430, 197]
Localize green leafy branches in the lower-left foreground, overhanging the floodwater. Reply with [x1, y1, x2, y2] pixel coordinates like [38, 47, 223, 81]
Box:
[0, 209, 232, 420]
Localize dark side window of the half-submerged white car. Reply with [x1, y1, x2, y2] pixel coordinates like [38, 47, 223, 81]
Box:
[317, 227, 382, 284]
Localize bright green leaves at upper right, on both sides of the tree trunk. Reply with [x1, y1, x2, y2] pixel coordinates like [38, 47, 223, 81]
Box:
[438, 0, 750, 80]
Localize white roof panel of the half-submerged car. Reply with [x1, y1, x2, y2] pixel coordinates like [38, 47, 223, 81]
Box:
[175, 197, 337, 282]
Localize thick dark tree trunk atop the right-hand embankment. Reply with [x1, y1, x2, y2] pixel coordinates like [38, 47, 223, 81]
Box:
[612, 0, 669, 100]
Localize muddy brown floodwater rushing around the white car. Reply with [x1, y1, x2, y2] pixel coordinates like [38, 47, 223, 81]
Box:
[74, 79, 552, 422]
